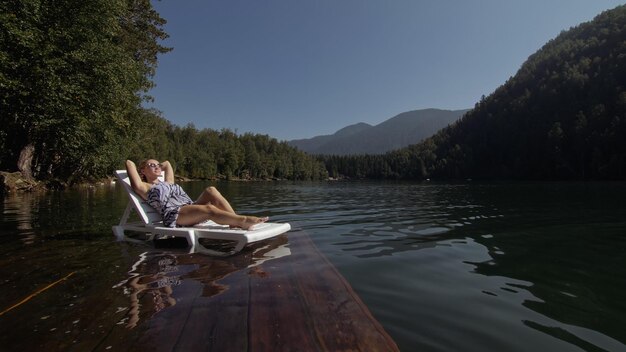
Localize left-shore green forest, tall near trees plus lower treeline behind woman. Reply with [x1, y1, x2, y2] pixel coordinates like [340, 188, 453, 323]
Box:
[0, 0, 326, 185]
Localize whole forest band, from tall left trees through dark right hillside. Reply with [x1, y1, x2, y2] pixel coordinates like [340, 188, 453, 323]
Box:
[0, 0, 626, 185]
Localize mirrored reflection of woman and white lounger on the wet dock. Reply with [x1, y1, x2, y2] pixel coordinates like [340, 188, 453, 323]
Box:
[113, 235, 291, 329]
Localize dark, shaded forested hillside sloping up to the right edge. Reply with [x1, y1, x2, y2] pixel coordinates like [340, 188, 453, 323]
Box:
[318, 6, 626, 180]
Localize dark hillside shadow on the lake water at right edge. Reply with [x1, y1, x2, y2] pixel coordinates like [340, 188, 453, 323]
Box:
[448, 184, 626, 351]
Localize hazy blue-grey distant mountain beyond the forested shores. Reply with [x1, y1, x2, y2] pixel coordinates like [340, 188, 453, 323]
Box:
[288, 109, 468, 155]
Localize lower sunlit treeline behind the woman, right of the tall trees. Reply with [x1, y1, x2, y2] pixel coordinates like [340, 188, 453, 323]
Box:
[127, 111, 328, 180]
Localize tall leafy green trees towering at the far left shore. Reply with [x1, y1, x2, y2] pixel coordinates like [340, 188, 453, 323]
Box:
[0, 0, 168, 182]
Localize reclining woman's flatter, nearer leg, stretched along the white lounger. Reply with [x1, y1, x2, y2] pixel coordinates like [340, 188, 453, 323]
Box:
[176, 204, 268, 230]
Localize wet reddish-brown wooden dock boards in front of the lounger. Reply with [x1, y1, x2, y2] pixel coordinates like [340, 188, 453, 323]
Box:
[99, 232, 398, 351]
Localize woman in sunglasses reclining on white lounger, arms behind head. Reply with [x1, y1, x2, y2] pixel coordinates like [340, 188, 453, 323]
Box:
[126, 159, 268, 230]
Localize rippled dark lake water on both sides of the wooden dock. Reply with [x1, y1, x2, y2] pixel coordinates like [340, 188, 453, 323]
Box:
[0, 182, 626, 351]
